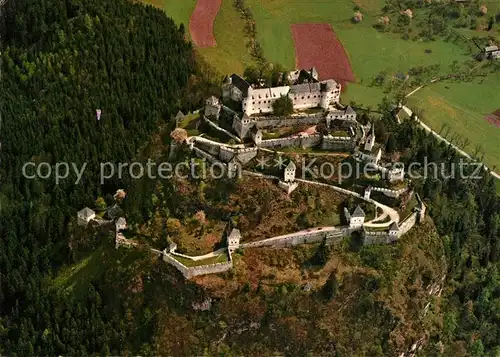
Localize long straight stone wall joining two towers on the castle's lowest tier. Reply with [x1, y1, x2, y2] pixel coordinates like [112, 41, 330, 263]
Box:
[240, 227, 351, 248]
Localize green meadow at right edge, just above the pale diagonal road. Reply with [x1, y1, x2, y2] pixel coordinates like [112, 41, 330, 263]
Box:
[408, 74, 500, 172]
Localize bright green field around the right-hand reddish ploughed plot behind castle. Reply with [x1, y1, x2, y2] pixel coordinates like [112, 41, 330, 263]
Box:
[246, 0, 469, 97]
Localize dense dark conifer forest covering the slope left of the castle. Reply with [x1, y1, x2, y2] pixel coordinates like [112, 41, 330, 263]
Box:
[0, 0, 194, 356]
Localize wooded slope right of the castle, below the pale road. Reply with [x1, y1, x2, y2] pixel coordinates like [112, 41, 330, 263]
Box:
[377, 106, 500, 357]
